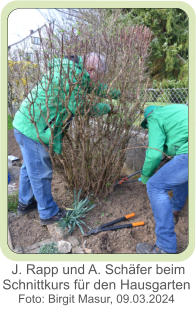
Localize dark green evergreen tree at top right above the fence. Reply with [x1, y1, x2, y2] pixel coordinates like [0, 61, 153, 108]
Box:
[140, 9, 188, 80]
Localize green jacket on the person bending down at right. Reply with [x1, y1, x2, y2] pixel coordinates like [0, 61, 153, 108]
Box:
[141, 104, 188, 184]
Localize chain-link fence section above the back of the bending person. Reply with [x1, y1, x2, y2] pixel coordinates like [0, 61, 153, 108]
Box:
[145, 88, 188, 104]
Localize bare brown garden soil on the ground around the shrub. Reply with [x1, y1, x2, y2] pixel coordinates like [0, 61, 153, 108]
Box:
[8, 131, 188, 254]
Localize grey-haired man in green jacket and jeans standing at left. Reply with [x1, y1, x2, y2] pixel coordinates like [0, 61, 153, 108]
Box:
[13, 52, 120, 225]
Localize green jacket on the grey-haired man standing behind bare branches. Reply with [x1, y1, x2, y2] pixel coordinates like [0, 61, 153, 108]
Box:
[13, 57, 120, 154]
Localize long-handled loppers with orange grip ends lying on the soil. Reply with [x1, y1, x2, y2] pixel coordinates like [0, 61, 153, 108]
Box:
[84, 212, 144, 236]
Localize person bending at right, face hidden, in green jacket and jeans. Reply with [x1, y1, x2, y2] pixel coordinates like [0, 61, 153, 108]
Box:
[136, 104, 188, 254]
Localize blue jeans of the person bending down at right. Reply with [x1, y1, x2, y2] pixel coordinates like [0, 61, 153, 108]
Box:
[146, 154, 188, 253]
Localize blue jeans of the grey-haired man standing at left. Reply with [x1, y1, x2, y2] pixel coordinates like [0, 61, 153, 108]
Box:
[14, 129, 59, 219]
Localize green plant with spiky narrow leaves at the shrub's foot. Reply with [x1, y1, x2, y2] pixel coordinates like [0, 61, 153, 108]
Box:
[59, 190, 95, 234]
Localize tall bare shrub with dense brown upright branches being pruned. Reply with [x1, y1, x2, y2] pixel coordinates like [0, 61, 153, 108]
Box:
[9, 18, 151, 196]
